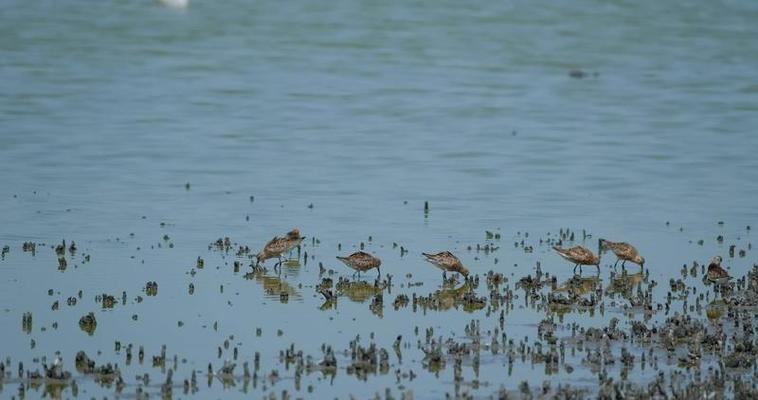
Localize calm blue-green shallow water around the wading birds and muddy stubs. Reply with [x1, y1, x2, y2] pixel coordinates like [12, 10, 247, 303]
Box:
[0, 0, 758, 398]
